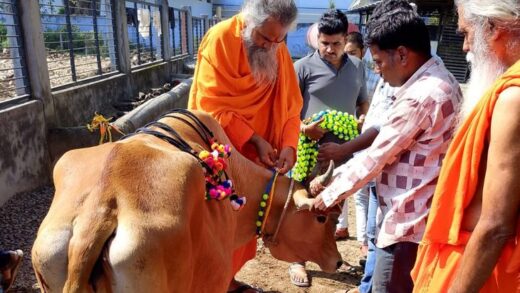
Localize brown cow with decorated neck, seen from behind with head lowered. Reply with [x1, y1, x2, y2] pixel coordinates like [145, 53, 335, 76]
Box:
[32, 112, 341, 292]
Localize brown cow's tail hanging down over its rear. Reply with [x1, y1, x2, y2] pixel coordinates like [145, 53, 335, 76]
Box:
[63, 195, 117, 292]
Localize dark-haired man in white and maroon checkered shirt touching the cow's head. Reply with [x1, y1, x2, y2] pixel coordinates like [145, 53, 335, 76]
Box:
[311, 0, 462, 292]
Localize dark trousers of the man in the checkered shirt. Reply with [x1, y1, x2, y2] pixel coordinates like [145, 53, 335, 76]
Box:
[372, 242, 419, 293]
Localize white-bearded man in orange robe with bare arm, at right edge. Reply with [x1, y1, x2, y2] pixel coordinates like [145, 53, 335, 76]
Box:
[412, 0, 520, 293]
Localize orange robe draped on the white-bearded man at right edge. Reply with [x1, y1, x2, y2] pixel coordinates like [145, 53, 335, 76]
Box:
[412, 61, 520, 293]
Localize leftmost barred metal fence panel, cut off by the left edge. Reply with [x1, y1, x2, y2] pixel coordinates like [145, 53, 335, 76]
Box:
[0, 0, 30, 101]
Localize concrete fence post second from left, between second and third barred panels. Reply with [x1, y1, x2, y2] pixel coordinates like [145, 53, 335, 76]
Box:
[112, 0, 131, 74]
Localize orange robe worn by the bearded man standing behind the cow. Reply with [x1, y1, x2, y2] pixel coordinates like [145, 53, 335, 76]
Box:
[188, 14, 303, 274]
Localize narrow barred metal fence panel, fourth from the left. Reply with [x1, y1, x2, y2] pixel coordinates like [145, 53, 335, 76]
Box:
[168, 7, 188, 56]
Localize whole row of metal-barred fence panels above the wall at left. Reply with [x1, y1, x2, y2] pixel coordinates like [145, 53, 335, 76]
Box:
[0, 0, 210, 105]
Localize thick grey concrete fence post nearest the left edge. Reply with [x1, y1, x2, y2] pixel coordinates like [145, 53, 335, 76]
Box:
[18, 0, 56, 128]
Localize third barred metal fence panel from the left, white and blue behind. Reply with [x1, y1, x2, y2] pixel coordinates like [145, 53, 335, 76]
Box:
[125, 0, 163, 66]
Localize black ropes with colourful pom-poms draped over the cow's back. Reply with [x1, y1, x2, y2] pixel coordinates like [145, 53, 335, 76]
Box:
[122, 109, 246, 211]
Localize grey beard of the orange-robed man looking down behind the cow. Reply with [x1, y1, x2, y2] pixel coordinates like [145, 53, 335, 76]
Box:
[242, 25, 278, 84]
